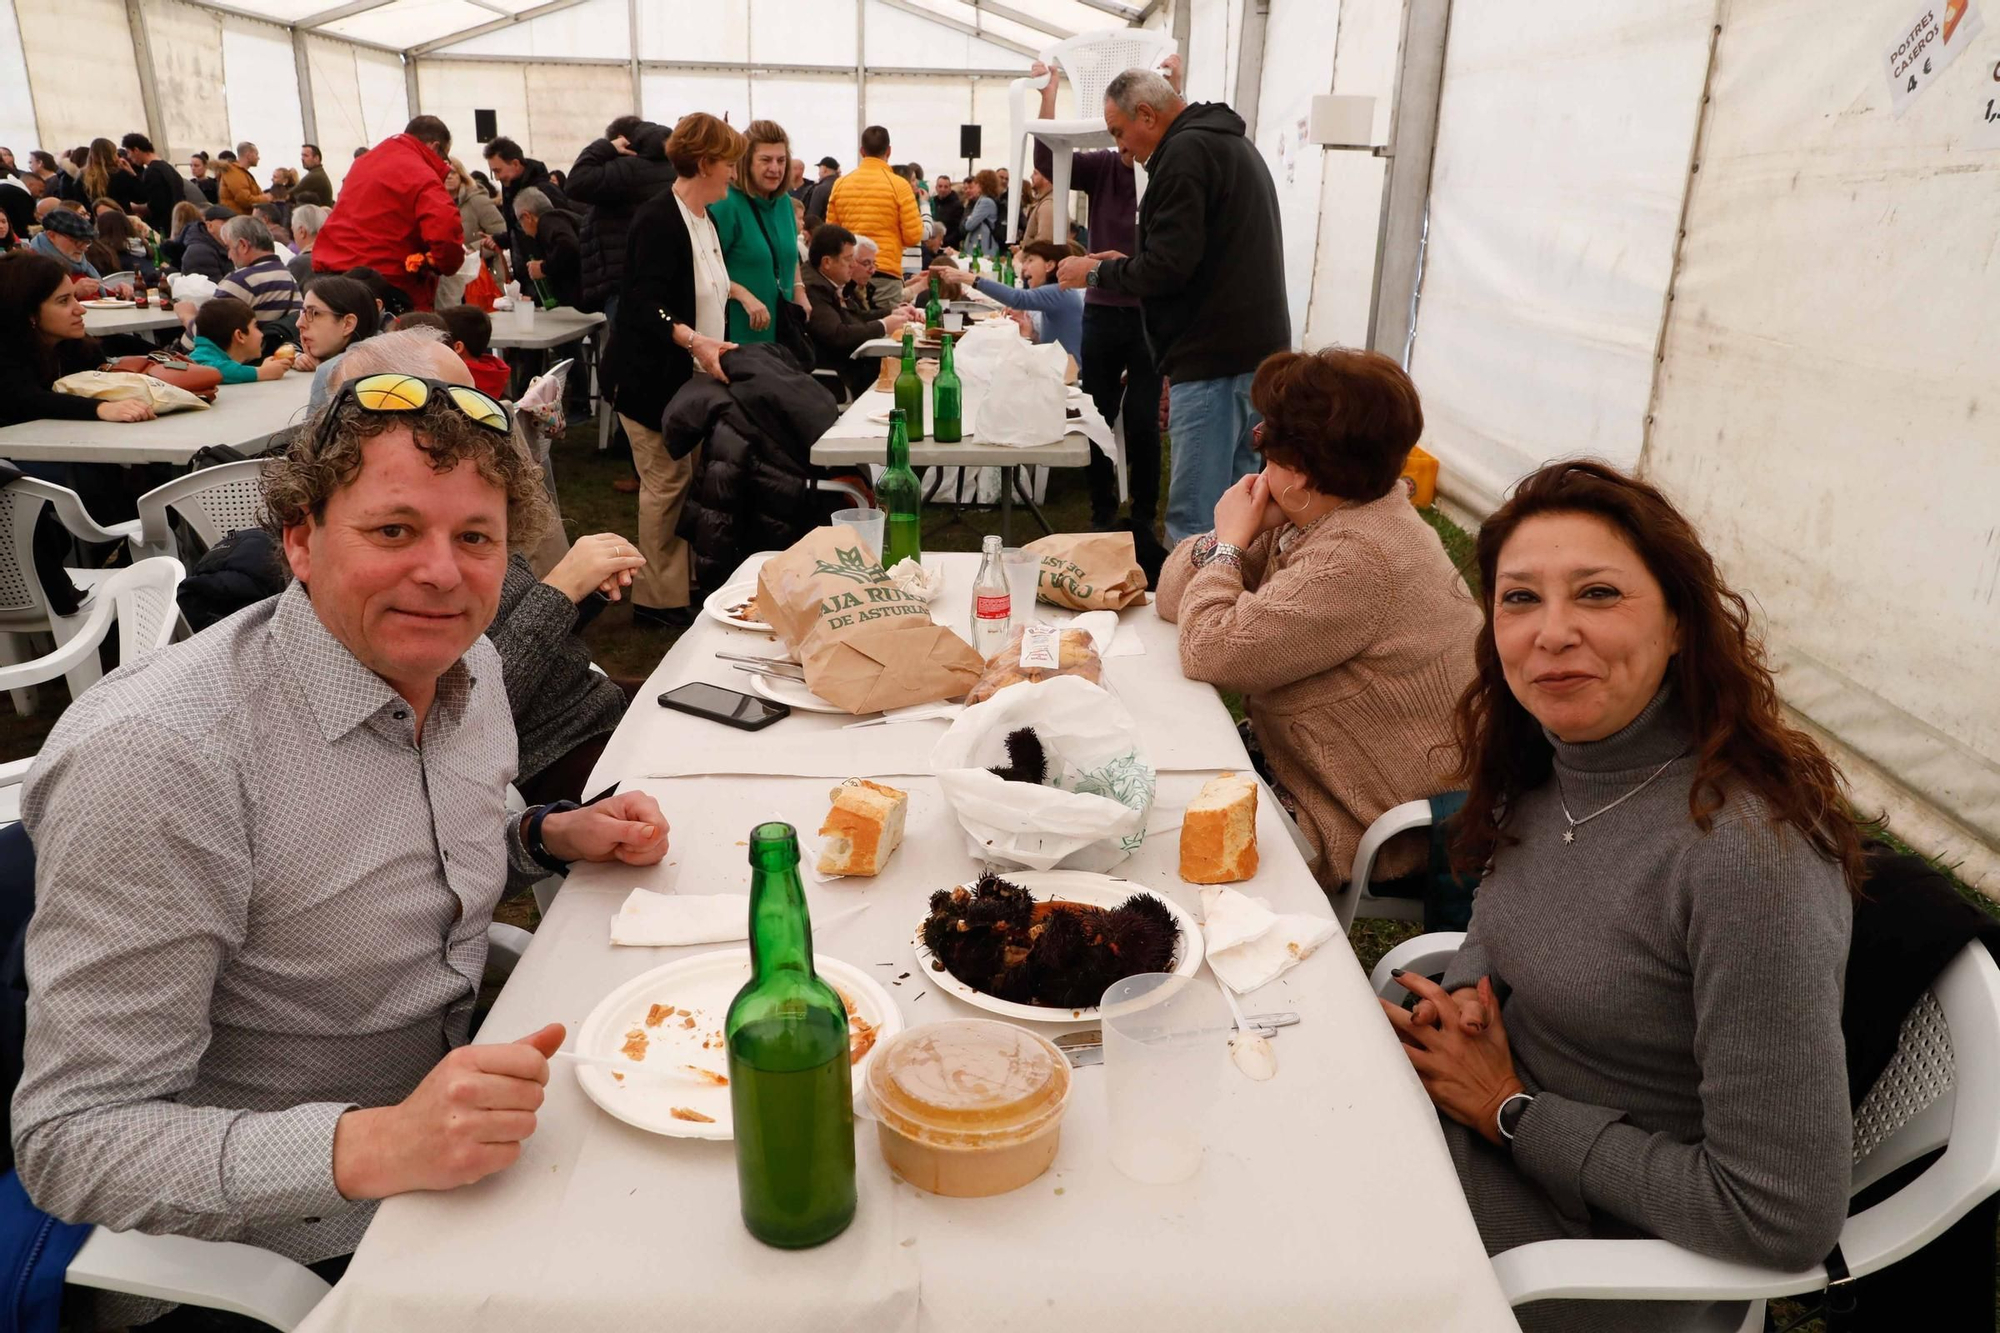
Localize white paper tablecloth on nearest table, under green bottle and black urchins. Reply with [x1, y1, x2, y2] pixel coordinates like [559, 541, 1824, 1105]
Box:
[304, 548, 1512, 1333]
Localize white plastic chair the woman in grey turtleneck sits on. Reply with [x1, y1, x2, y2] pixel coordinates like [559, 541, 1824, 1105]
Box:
[1370, 933, 2000, 1333]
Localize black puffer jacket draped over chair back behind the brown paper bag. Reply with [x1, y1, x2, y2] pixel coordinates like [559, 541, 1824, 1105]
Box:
[660, 342, 840, 588]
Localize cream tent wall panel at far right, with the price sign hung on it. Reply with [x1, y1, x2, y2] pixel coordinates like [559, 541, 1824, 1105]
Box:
[1640, 0, 2000, 844]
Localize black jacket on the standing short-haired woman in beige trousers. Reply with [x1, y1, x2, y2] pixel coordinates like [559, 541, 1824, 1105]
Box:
[604, 190, 694, 426]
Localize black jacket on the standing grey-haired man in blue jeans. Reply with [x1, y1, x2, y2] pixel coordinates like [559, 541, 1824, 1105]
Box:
[1098, 102, 1292, 382]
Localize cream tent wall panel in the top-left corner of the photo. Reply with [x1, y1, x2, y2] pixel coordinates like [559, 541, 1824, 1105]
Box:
[14, 0, 146, 152]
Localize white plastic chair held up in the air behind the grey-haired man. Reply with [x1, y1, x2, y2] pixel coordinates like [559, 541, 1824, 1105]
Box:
[1000, 28, 1180, 244]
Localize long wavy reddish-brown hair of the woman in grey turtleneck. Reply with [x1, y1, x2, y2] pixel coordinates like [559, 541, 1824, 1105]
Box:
[1454, 460, 1862, 893]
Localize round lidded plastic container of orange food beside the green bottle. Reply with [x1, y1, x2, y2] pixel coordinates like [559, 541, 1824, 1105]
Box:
[868, 1019, 1070, 1199]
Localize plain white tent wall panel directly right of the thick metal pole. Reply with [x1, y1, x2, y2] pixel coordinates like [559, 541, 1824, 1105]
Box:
[1400, 0, 1714, 504]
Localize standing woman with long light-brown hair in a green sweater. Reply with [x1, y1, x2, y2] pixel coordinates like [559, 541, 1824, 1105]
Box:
[708, 120, 806, 344]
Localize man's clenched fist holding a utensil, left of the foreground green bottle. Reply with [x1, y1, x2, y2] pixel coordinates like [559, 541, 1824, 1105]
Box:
[334, 1023, 564, 1199]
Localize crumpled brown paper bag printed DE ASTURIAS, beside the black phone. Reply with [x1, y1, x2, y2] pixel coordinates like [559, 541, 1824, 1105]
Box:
[756, 524, 984, 713]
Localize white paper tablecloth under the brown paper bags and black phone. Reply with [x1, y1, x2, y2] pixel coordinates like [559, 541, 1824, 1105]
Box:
[584, 552, 1242, 793]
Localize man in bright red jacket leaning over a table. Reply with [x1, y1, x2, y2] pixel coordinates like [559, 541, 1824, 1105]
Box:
[312, 116, 466, 310]
